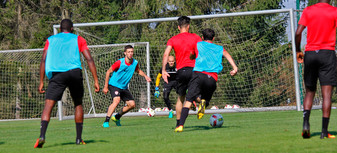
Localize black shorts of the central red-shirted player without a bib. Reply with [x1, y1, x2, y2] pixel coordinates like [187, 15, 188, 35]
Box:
[176, 67, 193, 96]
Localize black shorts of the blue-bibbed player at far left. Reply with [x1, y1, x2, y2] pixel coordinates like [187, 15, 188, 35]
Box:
[46, 69, 84, 105]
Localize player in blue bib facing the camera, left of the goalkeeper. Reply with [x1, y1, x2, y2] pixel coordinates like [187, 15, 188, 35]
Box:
[102, 45, 151, 128]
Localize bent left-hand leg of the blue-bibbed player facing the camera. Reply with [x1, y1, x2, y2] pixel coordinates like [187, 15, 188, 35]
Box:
[102, 85, 121, 128]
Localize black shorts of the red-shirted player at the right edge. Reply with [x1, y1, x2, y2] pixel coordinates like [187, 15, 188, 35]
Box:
[304, 50, 337, 91]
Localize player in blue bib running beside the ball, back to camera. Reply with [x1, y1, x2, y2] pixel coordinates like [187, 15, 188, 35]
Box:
[175, 29, 238, 132]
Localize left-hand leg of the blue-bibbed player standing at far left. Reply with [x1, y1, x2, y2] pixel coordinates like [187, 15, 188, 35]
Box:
[34, 73, 67, 148]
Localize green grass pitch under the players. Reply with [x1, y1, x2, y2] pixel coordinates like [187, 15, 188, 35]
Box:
[0, 110, 337, 153]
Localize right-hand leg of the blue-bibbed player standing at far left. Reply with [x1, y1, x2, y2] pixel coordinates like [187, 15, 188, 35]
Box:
[66, 69, 85, 145]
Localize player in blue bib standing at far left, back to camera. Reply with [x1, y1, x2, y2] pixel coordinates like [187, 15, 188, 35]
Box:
[34, 19, 99, 148]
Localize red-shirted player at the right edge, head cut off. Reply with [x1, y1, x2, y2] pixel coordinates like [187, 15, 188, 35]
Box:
[295, 0, 337, 139]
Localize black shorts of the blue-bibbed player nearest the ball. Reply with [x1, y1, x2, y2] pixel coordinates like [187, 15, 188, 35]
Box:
[186, 72, 216, 102]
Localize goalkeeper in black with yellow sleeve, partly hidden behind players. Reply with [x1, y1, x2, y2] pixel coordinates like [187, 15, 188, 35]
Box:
[154, 56, 177, 118]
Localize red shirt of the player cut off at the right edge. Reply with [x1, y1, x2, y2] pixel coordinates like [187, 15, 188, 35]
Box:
[298, 3, 337, 51]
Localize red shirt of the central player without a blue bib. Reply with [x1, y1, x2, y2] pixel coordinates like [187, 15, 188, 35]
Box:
[167, 32, 201, 70]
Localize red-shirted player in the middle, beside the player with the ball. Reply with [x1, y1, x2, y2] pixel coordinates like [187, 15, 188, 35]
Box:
[162, 16, 201, 126]
